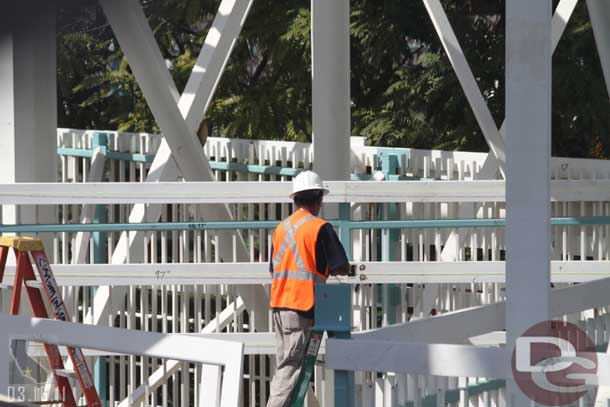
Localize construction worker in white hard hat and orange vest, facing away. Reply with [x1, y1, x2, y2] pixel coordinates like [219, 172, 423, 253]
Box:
[267, 171, 350, 407]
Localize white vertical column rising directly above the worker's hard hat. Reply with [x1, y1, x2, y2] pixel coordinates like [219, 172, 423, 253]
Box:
[311, 0, 351, 186]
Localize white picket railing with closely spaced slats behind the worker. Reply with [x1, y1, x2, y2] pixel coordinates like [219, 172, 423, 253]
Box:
[0, 130, 610, 406]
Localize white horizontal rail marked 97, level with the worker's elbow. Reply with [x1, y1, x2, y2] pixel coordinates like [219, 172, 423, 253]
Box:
[4, 261, 610, 286]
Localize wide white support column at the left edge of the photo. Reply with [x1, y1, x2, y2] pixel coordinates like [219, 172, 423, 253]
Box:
[0, 0, 57, 247]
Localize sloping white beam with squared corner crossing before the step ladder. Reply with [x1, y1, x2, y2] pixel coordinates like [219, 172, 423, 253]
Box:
[0, 314, 243, 407]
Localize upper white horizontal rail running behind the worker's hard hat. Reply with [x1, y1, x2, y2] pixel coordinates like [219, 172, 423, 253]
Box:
[0, 180, 610, 205]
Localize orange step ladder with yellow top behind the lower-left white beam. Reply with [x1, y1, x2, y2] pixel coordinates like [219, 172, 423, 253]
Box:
[0, 236, 102, 407]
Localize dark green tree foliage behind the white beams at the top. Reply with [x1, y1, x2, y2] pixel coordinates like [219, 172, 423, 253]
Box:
[58, 0, 610, 158]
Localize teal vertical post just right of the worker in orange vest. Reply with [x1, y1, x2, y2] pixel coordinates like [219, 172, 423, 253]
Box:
[334, 203, 355, 407]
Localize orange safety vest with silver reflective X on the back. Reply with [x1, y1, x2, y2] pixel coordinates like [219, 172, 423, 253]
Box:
[271, 209, 328, 311]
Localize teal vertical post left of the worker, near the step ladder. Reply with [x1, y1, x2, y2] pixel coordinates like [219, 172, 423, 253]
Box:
[91, 132, 108, 407]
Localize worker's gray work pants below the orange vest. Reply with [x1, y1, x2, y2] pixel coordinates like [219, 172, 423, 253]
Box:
[267, 311, 313, 407]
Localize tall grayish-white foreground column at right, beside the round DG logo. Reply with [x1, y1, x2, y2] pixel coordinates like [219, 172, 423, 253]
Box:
[506, 0, 552, 406]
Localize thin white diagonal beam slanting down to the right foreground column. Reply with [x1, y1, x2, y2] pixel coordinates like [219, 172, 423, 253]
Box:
[423, 0, 506, 178]
